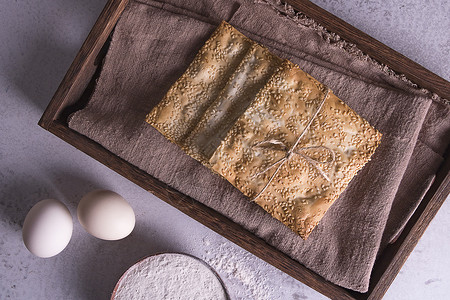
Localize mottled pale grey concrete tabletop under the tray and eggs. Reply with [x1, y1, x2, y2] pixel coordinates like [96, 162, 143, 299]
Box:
[0, 0, 450, 300]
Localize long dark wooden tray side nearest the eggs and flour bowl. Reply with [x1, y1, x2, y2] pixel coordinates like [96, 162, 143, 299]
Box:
[47, 121, 355, 299]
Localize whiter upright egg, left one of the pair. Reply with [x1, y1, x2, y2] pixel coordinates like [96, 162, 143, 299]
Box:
[22, 199, 73, 258]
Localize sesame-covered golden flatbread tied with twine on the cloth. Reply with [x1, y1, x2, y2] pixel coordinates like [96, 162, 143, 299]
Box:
[146, 22, 382, 239]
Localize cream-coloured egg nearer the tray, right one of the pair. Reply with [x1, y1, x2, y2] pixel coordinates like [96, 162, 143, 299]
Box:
[77, 190, 136, 241]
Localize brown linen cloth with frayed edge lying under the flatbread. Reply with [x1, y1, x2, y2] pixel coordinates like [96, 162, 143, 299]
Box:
[69, 0, 450, 292]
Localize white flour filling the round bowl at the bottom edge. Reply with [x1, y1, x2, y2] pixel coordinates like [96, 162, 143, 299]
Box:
[112, 253, 226, 300]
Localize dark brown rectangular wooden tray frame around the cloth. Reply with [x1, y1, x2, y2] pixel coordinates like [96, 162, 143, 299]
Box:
[39, 0, 450, 299]
